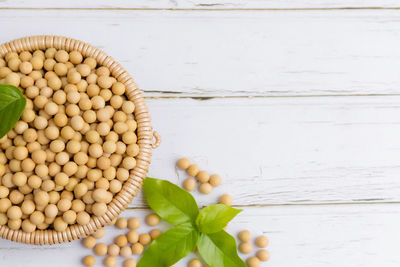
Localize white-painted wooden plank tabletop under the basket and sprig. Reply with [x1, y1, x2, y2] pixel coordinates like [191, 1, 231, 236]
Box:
[0, 0, 400, 267]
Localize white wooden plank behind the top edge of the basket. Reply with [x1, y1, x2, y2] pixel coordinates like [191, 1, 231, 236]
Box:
[0, 9, 400, 97]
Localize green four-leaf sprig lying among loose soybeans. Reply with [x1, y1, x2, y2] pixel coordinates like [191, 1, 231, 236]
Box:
[137, 178, 246, 267]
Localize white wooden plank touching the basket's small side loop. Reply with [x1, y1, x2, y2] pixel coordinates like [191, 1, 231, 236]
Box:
[123, 97, 400, 207]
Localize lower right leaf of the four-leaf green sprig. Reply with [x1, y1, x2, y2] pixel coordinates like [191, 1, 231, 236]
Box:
[197, 231, 246, 267]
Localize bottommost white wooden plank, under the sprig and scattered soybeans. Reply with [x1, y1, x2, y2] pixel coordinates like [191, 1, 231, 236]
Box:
[0, 204, 400, 267]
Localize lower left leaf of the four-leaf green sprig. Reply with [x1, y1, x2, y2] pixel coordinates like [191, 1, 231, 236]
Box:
[137, 224, 200, 267]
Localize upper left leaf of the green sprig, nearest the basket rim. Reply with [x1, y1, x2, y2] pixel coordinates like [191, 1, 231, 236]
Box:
[143, 177, 199, 225]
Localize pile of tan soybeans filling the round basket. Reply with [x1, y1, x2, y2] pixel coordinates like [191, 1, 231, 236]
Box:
[0, 48, 139, 233]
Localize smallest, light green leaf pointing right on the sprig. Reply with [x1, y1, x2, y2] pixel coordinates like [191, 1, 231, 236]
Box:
[196, 204, 242, 234]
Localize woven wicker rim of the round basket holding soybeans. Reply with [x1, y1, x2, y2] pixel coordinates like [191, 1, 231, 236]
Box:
[0, 36, 161, 245]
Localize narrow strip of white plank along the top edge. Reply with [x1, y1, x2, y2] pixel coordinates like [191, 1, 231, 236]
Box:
[0, 0, 399, 10]
